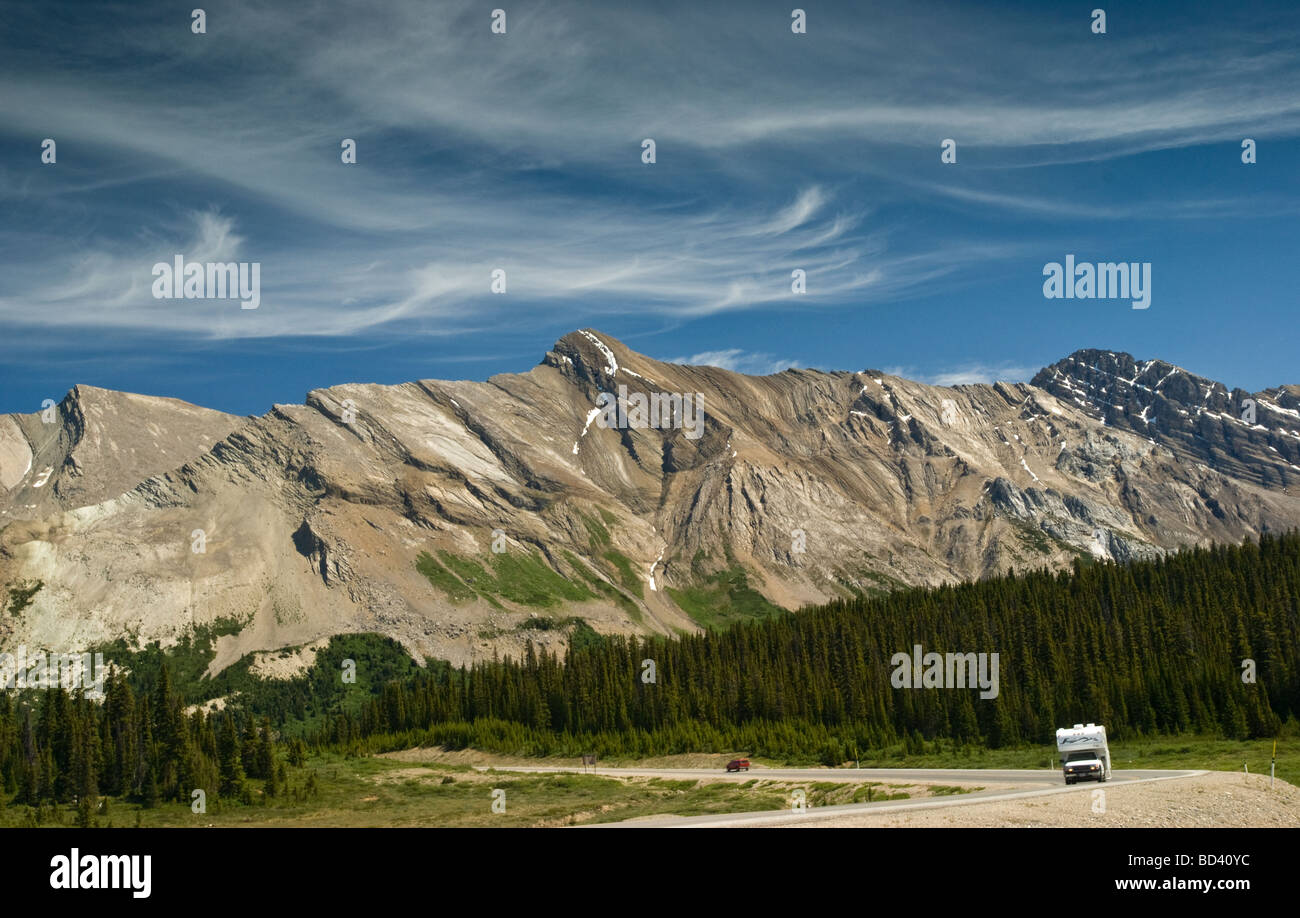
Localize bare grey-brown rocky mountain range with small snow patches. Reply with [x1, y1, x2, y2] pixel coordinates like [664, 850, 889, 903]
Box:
[0, 329, 1300, 672]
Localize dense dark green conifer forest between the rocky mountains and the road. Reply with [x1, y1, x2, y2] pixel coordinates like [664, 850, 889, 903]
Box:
[0, 533, 1300, 802]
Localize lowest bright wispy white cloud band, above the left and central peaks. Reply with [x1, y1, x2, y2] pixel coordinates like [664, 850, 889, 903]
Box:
[0, 187, 883, 338]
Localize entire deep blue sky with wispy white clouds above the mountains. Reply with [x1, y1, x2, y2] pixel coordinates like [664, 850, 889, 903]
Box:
[0, 0, 1300, 413]
